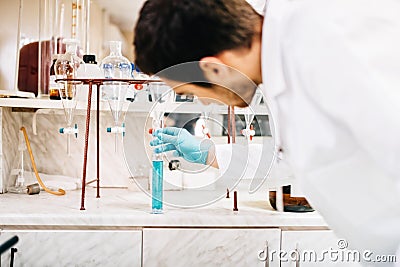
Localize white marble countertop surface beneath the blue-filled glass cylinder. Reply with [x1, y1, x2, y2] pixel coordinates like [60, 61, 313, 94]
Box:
[0, 188, 327, 229]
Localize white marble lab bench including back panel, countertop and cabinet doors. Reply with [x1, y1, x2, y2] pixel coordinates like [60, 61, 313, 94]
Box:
[0, 99, 356, 267]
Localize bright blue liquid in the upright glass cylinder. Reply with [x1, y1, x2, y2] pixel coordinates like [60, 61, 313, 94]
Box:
[151, 160, 163, 214]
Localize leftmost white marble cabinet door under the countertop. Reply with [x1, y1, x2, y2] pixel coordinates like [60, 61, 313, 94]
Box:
[0, 230, 142, 267]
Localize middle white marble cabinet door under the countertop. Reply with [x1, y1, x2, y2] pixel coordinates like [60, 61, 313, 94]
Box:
[143, 229, 280, 267]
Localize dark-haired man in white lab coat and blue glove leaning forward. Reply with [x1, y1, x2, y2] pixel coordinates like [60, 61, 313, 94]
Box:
[134, 0, 400, 261]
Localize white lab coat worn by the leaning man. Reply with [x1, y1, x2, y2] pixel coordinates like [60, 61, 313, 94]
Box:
[217, 0, 400, 260]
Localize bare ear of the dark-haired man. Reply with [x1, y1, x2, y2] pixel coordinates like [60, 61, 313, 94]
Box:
[199, 57, 229, 83]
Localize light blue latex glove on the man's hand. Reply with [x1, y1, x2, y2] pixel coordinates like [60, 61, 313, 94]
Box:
[150, 127, 212, 164]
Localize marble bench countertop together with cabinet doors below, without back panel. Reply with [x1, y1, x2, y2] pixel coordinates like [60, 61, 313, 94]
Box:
[0, 188, 360, 266]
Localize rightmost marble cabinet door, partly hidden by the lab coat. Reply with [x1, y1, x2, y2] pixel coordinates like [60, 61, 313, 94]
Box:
[280, 230, 362, 267]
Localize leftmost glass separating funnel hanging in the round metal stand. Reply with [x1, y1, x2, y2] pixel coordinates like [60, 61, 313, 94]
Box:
[54, 39, 82, 155]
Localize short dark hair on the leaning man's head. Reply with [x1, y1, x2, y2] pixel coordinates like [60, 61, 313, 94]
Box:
[134, 0, 259, 81]
